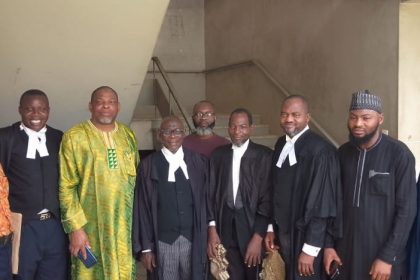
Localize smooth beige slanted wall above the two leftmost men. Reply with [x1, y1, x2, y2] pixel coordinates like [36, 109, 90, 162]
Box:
[0, 0, 169, 129]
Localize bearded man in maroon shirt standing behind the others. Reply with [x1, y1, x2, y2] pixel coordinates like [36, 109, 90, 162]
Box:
[183, 100, 230, 157]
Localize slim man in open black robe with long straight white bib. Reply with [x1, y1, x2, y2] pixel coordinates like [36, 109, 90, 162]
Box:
[207, 108, 272, 280]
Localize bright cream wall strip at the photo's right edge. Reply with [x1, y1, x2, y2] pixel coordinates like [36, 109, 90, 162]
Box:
[398, 3, 420, 174]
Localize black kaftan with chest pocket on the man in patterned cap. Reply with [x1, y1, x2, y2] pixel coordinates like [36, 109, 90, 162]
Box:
[336, 135, 417, 280]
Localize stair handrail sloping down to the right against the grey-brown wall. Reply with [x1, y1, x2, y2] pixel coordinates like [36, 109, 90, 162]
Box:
[203, 59, 339, 148]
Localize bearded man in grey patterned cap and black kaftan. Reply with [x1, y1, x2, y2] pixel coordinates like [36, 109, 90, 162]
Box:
[324, 91, 416, 280]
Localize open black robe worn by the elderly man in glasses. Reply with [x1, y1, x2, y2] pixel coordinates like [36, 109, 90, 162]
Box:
[133, 148, 208, 280]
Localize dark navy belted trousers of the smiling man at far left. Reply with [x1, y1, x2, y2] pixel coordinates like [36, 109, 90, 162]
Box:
[14, 218, 69, 280]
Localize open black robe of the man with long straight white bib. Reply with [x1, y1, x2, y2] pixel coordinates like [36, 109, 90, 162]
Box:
[207, 141, 272, 253]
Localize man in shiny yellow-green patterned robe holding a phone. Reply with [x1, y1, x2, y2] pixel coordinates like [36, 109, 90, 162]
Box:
[60, 86, 139, 280]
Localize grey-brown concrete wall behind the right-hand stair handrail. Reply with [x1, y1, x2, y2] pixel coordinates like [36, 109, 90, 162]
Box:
[205, 0, 399, 143]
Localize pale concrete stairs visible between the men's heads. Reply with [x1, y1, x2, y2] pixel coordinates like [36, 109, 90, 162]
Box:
[130, 104, 278, 151]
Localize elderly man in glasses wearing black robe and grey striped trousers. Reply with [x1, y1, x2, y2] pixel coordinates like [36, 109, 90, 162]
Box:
[133, 116, 208, 280]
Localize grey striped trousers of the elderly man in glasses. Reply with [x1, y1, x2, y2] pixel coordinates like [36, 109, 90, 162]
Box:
[158, 235, 191, 280]
